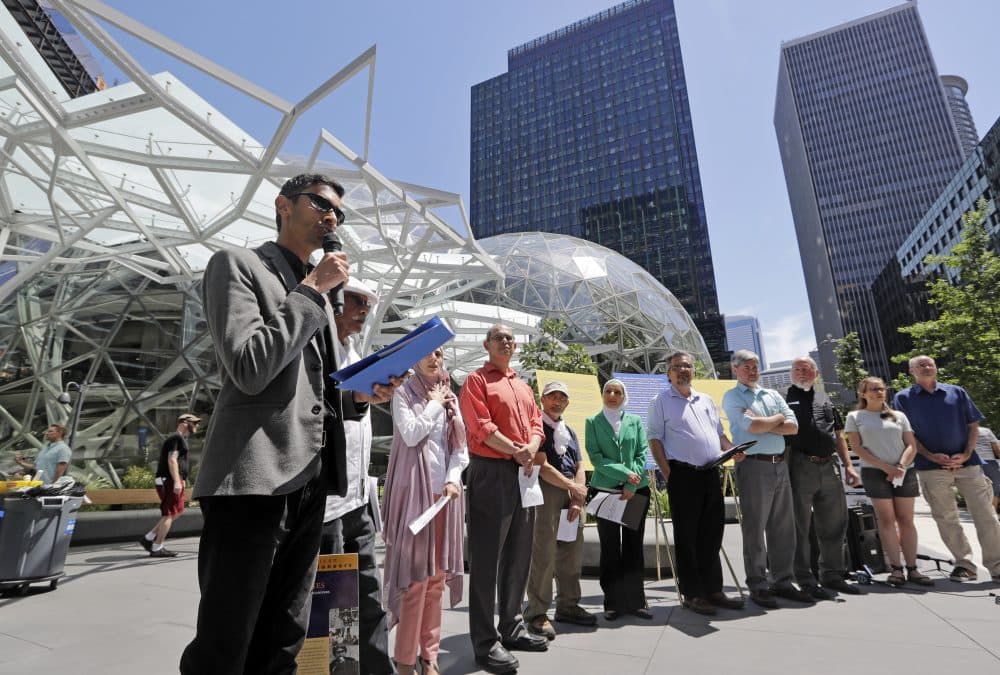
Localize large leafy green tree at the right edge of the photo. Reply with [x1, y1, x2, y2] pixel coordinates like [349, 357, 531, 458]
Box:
[893, 199, 1000, 424]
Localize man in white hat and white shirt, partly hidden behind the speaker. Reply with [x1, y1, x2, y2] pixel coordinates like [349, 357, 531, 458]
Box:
[320, 277, 396, 674]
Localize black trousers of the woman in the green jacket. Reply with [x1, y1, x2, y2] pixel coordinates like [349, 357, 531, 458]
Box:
[597, 488, 649, 612]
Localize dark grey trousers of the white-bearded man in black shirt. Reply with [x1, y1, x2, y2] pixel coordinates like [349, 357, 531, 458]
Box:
[788, 450, 847, 585]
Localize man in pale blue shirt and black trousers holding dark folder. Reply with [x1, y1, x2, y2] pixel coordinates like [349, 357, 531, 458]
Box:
[646, 352, 743, 615]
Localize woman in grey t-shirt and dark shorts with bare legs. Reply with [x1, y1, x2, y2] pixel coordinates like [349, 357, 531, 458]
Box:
[846, 377, 934, 586]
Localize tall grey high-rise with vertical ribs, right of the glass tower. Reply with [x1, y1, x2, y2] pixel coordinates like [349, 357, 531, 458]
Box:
[774, 2, 964, 383]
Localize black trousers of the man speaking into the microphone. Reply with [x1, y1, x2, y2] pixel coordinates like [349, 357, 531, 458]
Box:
[180, 478, 326, 675]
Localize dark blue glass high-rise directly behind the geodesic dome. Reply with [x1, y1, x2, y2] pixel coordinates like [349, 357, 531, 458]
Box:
[471, 0, 728, 371]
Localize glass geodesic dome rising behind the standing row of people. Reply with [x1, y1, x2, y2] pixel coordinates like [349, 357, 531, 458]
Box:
[467, 232, 713, 377]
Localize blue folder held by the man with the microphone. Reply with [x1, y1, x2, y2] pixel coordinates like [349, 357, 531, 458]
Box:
[330, 316, 455, 394]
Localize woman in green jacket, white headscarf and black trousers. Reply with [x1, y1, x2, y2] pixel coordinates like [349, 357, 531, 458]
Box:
[586, 380, 653, 621]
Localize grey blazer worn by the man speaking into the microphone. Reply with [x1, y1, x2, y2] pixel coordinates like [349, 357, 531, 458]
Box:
[193, 242, 358, 498]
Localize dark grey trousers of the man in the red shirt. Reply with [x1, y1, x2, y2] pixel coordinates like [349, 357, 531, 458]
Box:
[466, 455, 535, 656]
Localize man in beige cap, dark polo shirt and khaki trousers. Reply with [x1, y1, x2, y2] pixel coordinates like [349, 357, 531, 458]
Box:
[524, 381, 597, 640]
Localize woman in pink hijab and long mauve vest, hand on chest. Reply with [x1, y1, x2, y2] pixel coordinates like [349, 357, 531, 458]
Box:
[382, 348, 469, 675]
